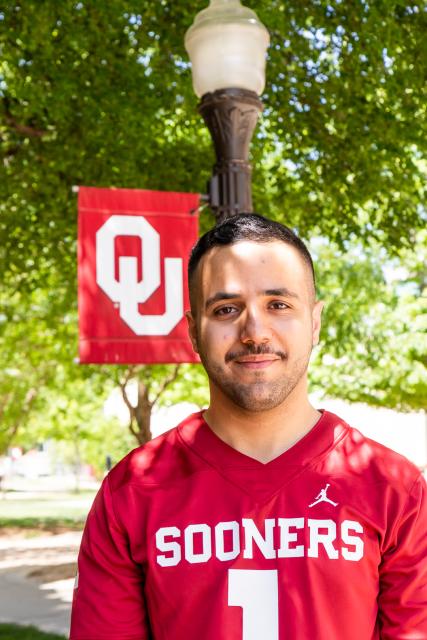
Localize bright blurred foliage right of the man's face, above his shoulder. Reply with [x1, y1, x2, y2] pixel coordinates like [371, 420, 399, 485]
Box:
[311, 232, 427, 411]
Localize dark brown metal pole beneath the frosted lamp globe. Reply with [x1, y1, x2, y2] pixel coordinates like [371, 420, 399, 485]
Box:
[199, 89, 262, 222]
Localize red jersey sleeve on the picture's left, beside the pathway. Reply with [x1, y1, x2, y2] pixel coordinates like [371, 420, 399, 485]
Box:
[70, 476, 151, 640]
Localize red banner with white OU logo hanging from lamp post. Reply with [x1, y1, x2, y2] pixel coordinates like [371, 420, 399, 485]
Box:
[78, 187, 199, 364]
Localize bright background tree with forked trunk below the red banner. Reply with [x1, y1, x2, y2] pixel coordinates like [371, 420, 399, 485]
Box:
[0, 282, 207, 452]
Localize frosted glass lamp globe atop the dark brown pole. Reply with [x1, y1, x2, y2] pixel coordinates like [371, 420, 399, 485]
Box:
[185, 0, 270, 97]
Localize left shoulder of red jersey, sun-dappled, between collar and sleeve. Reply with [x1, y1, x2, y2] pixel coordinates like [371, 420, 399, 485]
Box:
[108, 412, 202, 493]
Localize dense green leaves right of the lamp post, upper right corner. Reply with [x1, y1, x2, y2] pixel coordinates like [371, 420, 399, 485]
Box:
[253, 0, 427, 248]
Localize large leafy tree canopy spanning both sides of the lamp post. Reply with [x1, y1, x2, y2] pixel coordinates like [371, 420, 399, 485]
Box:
[0, 0, 427, 450]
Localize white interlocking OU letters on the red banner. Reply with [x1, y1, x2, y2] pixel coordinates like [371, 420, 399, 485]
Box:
[96, 215, 184, 336]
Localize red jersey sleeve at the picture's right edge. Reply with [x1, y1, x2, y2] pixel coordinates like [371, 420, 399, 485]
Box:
[378, 475, 427, 640]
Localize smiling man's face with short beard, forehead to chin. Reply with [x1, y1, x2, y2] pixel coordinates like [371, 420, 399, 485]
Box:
[188, 241, 322, 411]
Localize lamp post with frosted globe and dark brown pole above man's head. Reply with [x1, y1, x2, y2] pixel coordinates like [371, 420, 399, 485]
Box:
[185, 0, 270, 222]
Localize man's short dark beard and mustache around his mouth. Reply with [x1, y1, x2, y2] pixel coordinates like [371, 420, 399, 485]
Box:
[198, 345, 311, 412]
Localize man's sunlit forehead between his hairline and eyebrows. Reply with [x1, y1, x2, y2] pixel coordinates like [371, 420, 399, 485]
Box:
[197, 240, 313, 300]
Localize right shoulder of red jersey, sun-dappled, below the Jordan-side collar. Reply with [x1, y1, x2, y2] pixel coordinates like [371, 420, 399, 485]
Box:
[326, 416, 423, 492]
